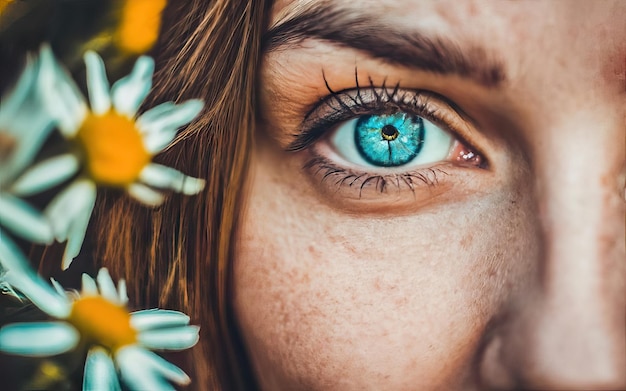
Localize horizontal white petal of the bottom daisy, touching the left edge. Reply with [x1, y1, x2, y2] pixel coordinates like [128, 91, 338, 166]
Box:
[0, 322, 79, 357]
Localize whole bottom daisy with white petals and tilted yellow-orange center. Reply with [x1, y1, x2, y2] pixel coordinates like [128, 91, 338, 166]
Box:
[0, 268, 199, 391]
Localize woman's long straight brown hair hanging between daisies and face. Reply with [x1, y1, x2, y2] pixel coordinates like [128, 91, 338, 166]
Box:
[88, 0, 270, 390]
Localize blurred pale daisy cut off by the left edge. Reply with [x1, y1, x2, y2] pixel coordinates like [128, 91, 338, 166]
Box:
[0, 47, 69, 269]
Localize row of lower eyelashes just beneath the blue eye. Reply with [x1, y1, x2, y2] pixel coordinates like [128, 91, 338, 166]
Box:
[303, 156, 448, 198]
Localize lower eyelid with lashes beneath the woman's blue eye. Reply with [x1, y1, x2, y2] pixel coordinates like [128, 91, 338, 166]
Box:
[297, 135, 491, 215]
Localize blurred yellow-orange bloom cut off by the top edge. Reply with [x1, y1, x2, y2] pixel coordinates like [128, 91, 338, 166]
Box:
[116, 0, 166, 54]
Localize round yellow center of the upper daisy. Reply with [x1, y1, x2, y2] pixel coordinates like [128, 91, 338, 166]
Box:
[76, 111, 152, 187]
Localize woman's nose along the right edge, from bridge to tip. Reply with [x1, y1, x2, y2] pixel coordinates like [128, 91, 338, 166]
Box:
[516, 115, 626, 389]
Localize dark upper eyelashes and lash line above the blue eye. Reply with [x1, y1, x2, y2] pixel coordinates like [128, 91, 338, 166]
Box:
[286, 68, 448, 152]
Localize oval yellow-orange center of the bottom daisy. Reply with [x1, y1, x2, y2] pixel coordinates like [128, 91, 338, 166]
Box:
[67, 296, 137, 352]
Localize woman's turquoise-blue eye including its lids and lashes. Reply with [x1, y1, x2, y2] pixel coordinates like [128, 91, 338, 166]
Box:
[290, 73, 489, 208]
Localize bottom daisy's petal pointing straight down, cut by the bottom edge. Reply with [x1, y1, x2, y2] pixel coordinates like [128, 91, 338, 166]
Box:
[83, 348, 121, 391]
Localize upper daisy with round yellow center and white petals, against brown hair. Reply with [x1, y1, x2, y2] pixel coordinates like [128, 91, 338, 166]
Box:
[27, 46, 204, 269]
